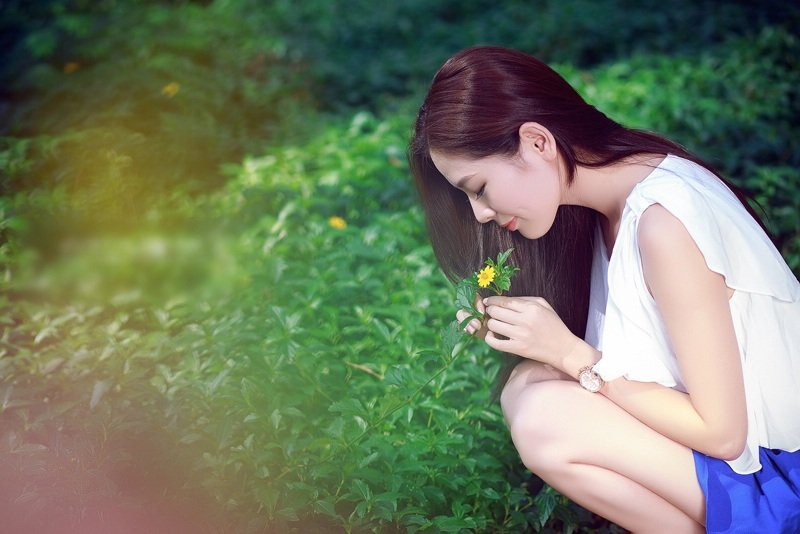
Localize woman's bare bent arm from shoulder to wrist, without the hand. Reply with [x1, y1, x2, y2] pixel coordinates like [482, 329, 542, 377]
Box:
[559, 204, 747, 460]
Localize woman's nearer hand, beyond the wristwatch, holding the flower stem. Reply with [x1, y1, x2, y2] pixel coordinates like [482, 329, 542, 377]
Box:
[484, 297, 581, 369]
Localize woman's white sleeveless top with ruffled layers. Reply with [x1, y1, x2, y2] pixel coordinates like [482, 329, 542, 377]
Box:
[586, 155, 800, 474]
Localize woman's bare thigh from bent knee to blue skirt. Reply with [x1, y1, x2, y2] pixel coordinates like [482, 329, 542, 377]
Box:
[507, 380, 705, 523]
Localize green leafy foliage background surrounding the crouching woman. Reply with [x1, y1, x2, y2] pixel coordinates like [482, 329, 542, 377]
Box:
[0, 0, 800, 532]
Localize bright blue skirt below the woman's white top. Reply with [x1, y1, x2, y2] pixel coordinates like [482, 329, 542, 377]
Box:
[692, 448, 800, 534]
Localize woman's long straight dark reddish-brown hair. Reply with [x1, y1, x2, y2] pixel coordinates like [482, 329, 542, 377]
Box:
[408, 46, 763, 394]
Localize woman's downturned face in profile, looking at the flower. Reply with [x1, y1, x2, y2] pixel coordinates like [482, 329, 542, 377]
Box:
[431, 144, 562, 239]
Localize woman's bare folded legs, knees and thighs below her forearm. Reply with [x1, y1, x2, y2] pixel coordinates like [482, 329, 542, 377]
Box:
[501, 362, 705, 532]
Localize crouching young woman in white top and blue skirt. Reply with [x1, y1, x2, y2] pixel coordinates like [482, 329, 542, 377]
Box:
[409, 47, 800, 533]
